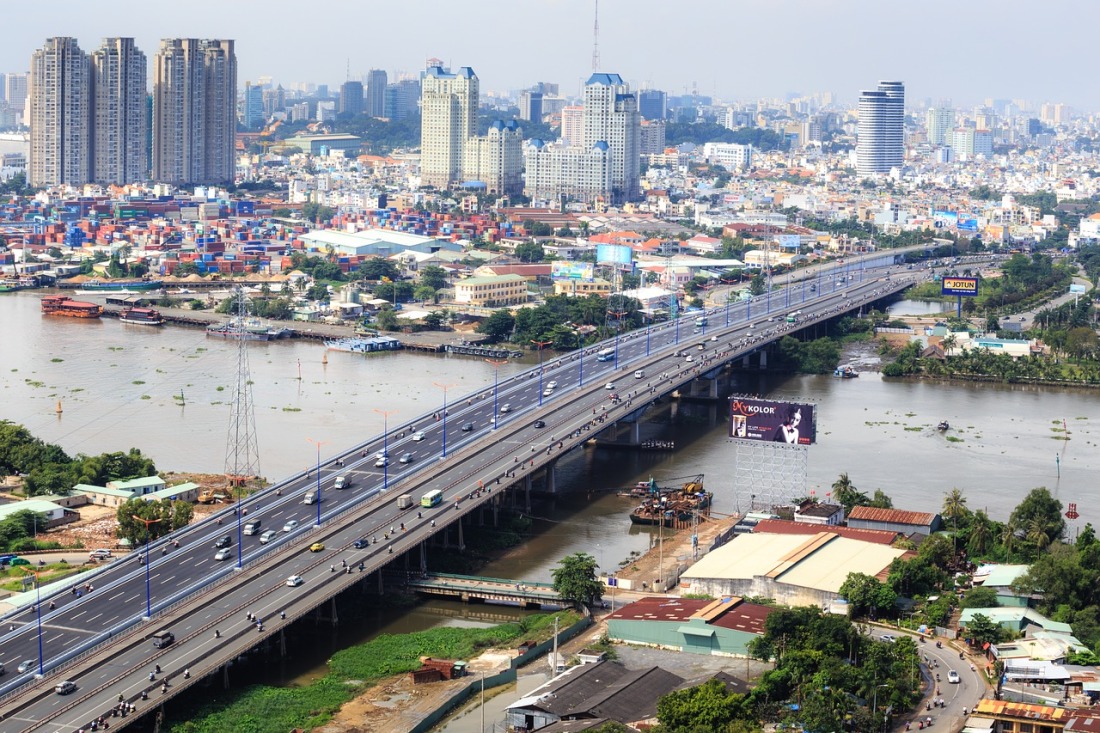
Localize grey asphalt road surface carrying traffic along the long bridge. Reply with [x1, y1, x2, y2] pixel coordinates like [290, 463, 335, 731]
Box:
[0, 260, 919, 731]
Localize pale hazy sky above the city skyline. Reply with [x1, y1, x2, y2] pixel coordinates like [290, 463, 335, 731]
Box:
[0, 0, 1100, 112]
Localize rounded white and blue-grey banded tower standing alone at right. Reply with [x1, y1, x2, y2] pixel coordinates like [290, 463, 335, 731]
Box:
[856, 81, 905, 176]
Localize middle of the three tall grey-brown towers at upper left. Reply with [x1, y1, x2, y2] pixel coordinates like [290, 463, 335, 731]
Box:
[91, 39, 149, 184]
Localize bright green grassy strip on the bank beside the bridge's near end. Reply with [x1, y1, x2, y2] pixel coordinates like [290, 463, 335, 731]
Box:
[168, 612, 578, 733]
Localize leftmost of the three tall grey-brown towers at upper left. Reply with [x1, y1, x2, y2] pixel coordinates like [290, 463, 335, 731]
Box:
[28, 37, 92, 186]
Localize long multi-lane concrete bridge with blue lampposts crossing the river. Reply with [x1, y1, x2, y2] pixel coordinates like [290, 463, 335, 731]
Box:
[0, 254, 917, 733]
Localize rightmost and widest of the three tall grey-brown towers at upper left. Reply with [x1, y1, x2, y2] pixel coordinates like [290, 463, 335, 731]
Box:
[153, 39, 237, 184]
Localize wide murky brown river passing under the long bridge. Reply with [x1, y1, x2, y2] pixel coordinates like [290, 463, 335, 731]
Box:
[0, 293, 1100, 717]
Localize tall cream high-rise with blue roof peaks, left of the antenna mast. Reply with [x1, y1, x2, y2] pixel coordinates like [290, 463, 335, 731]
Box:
[420, 66, 477, 188]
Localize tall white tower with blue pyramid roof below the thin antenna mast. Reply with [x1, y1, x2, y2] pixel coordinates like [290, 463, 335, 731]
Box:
[582, 73, 641, 203]
